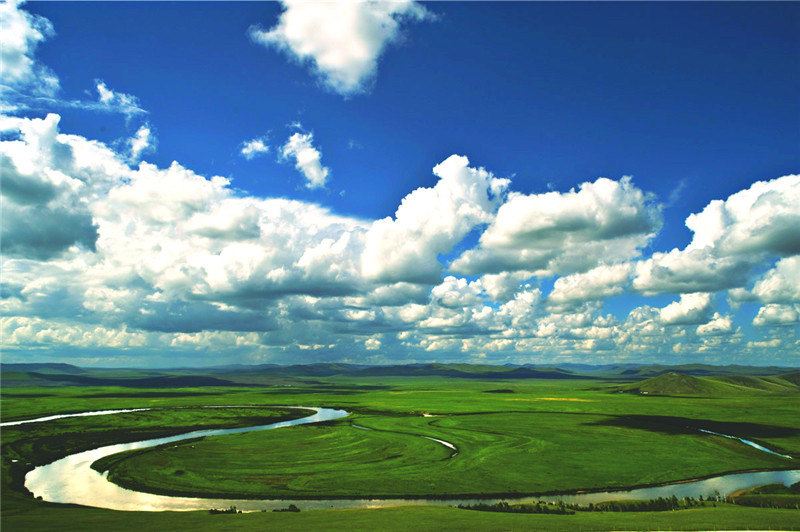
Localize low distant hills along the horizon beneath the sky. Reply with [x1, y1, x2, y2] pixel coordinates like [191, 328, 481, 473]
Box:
[0, 363, 800, 393]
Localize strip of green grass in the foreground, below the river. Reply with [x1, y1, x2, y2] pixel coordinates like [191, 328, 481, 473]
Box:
[0, 504, 800, 531]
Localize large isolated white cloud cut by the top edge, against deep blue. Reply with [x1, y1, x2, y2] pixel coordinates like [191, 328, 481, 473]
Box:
[249, 0, 428, 95]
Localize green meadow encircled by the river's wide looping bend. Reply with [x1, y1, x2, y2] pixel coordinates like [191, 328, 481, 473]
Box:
[97, 412, 792, 498]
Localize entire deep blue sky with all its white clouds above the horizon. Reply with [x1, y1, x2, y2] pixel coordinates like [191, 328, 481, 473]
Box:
[0, 0, 800, 367]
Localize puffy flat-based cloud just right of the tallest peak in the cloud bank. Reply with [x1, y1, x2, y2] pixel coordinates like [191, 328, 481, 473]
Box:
[451, 178, 661, 276]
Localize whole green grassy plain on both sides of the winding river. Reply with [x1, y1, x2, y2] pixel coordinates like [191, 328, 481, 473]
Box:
[0, 376, 800, 530]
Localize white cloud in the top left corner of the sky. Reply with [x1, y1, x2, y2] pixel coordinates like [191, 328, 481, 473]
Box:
[0, 0, 59, 103]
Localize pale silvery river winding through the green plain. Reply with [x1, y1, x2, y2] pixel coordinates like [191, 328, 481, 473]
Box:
[12, 407, 800, 511]
